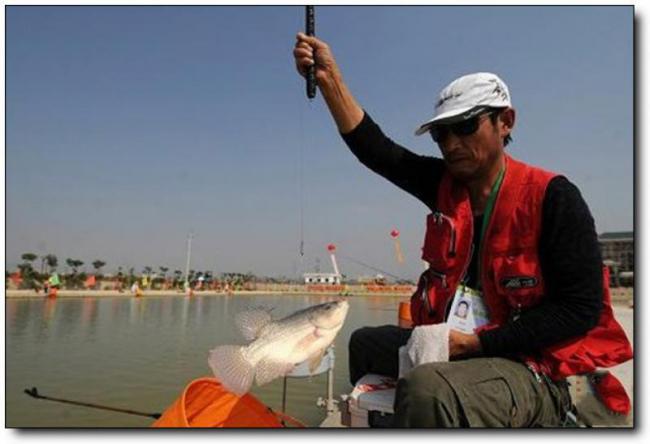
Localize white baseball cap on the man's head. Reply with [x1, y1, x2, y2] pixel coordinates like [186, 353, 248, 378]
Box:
[415, 72, 512, 136]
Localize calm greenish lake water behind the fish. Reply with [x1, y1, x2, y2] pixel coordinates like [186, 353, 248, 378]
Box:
[5, 295, 406, 427]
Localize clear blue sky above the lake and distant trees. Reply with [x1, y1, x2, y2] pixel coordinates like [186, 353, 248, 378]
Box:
[6, 6, 633, 277]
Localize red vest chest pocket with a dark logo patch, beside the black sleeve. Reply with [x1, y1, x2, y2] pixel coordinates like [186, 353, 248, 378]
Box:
[492, 251, 544, 309]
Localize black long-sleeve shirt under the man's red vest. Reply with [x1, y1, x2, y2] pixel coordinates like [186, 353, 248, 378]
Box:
[342, 113, 603, 356]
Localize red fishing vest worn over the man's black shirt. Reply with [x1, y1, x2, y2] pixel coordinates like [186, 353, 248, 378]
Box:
[411, 156, 632, 386]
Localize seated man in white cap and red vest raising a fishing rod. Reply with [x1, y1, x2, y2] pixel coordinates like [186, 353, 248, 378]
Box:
[294, 33, 632, 427]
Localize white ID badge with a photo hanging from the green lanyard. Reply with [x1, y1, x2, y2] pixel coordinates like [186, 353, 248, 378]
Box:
[447, 285, 489, 334]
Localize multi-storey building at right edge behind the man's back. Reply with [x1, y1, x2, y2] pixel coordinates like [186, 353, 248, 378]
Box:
[598, 231, 634, 287]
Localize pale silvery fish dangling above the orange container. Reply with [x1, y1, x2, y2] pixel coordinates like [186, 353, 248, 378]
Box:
[208, 300, 349, 396]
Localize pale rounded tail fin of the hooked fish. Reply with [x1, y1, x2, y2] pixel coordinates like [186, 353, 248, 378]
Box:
[208, 345, 255, 396]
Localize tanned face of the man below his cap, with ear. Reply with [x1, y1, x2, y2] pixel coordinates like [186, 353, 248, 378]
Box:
[428, 108, 514, 182]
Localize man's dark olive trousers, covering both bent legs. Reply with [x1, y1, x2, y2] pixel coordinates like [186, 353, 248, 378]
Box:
[349, 325, 571, 428]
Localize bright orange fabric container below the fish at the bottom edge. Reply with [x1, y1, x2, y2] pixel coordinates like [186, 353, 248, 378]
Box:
[151, 378, 303, 428]
